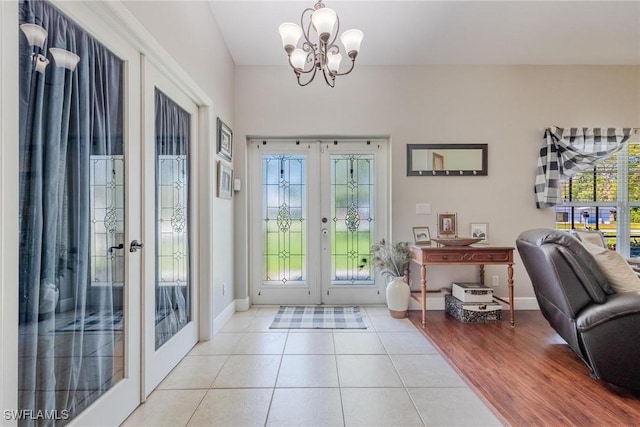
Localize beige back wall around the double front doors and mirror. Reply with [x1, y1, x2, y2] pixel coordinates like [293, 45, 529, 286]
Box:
[234, 64, 640, 301]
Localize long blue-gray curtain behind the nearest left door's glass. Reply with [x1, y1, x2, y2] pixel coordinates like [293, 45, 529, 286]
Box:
[18, 1, 123, 425]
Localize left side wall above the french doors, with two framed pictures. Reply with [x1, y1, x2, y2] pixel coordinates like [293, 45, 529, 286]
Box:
[124, 1, 234, 317]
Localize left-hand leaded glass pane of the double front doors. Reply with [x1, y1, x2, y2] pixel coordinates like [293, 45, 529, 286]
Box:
[262, 154, 307, 286]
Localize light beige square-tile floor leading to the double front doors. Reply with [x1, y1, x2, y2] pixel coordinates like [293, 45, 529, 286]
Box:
[123, 307, 501, 427]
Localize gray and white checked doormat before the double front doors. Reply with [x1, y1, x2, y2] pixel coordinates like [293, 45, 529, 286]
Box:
[269, 306, 367, 329]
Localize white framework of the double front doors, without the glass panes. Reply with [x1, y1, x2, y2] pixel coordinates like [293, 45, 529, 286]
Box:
[248, 137, 391, 305]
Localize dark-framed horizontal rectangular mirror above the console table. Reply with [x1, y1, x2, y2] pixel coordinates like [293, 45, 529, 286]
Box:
[407, 144, 488, 176]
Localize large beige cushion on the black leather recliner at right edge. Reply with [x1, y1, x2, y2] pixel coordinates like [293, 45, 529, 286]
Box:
[582, 241, 640, 292]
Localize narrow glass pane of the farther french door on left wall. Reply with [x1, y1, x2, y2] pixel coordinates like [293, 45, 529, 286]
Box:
[155, 89, 191, 349]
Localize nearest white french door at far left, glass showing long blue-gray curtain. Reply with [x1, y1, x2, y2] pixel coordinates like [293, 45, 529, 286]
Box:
[16, 2, 142, 426]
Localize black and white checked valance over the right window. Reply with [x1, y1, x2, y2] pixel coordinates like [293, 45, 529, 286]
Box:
[535, 127, 633, 208]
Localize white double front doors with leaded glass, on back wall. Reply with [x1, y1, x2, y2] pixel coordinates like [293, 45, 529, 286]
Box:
[249, 140, 388, 304]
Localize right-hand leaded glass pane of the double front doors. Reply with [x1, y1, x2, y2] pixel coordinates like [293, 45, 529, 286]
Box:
[331, 154, 375, 285]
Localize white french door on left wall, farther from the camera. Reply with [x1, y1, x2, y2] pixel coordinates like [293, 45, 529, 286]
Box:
[139, 60, 198, 396]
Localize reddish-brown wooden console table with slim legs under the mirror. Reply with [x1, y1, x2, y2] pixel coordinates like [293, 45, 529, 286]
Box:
[409, 245, 515, 326]
